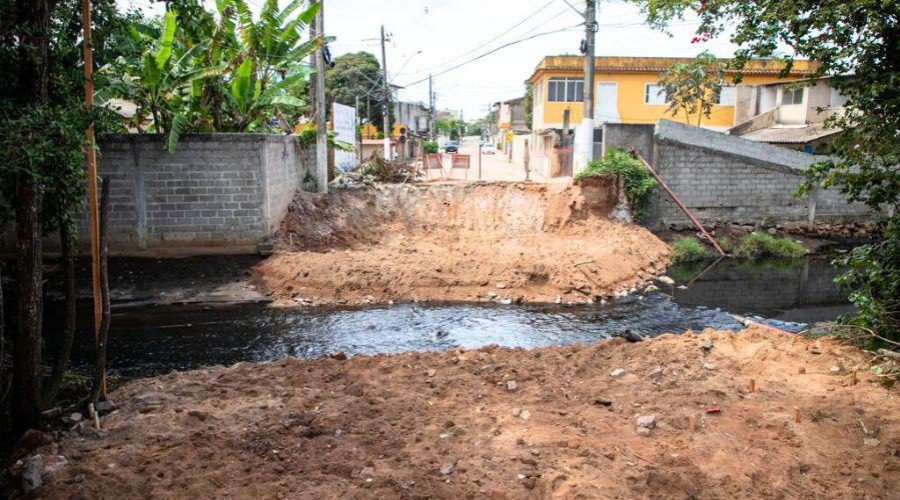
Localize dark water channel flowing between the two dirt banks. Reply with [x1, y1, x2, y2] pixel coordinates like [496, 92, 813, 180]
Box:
[61, 260, 850, 377]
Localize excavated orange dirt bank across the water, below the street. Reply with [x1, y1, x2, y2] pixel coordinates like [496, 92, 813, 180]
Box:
[255, 177, 668, 304]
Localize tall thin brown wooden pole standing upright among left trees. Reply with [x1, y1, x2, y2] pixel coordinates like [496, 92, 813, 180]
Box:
[81, 0, 105, 385]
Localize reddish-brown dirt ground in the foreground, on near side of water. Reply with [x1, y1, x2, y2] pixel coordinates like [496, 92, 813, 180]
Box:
[37, 327, 900, 499]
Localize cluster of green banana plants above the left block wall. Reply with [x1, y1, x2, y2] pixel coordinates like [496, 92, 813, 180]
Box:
[96, 0, 325, 152]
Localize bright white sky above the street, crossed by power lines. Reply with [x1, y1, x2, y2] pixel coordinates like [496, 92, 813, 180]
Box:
[118, 0, 752, 120]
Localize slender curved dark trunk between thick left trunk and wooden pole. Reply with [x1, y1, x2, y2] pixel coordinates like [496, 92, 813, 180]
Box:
[41, 224, 77, 409]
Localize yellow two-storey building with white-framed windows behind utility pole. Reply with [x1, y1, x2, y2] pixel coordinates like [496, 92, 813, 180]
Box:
[528, 56, 815, 131]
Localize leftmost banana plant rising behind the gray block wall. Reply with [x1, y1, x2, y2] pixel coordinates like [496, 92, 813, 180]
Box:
[96, 11, 223, 152]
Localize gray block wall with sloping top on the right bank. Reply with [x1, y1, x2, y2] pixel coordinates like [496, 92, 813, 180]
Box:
[648, 121, 870, 227]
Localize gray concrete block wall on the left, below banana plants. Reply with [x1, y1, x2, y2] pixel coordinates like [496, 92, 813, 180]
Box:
[2, 134, 313, 256]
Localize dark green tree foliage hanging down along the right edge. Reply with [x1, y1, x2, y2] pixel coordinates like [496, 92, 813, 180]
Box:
[631, 0, 900, 341]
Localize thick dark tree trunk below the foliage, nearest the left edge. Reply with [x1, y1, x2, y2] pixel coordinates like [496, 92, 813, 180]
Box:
[12, 180, 43, 433]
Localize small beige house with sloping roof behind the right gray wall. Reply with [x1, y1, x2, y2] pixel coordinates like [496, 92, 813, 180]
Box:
[728, 77, 847, 154]
